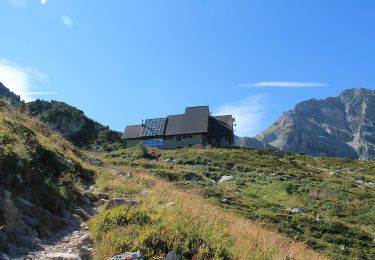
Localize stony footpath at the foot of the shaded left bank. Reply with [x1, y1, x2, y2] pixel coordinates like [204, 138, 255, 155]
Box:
[23, 209, 96, 260]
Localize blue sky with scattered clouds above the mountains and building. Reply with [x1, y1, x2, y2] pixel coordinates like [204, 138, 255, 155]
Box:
[0, 0, 375, 136]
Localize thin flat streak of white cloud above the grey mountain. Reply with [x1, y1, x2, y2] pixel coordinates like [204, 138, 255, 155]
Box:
[239, 81, 328, 88]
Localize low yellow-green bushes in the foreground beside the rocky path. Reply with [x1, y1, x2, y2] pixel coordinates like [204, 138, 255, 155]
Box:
[89, 206, 231, 259]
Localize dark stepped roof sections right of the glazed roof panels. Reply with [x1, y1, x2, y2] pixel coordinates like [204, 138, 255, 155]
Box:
[165, 106, 209, 135]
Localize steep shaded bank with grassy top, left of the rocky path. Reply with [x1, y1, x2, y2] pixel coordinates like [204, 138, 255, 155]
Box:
[0, 100, 95, 257]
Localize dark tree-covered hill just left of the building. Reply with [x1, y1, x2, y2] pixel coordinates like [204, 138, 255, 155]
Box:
[26, 100, 121, 150]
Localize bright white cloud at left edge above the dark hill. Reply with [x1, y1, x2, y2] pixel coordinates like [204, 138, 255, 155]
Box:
[0, 59, 57, 101]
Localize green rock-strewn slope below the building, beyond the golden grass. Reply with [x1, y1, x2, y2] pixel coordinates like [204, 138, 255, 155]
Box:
[100, 148, 375, 259]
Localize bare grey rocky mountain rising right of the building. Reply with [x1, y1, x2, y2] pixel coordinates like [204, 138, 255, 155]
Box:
[256, 88, 375, 160]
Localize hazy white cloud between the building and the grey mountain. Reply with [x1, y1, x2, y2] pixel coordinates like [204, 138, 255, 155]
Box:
[214, 94, 266, 136]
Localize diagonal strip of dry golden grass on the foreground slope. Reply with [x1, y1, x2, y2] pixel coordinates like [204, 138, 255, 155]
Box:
[93, 167, 324, 259]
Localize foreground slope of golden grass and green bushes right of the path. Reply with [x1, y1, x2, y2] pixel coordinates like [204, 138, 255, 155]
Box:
[89, 161, 324, 259]
